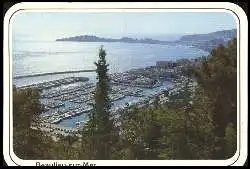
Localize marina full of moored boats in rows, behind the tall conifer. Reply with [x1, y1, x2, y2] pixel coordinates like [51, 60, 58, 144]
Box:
[15, 62, 197, 135]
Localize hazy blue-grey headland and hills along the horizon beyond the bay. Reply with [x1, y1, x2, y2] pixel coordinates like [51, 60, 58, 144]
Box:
[56, 29, 237, 52]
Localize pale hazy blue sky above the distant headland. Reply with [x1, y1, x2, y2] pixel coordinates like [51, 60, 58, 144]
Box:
[12, 12, 236, 40]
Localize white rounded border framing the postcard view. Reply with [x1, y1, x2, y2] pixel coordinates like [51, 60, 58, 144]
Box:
[3, 2, 248, 166]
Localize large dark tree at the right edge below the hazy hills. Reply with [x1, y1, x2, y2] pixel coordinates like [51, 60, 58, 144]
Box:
[195, 38, 237, 159]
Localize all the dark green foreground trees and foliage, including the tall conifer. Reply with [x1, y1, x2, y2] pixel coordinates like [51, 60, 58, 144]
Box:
[13, 39, 237, 160]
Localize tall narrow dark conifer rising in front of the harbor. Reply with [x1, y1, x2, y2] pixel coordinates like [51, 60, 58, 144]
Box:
[85, 46, 114, 160]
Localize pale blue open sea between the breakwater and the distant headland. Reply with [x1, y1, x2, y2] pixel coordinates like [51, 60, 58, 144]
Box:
[12, 41, 208, 83]
